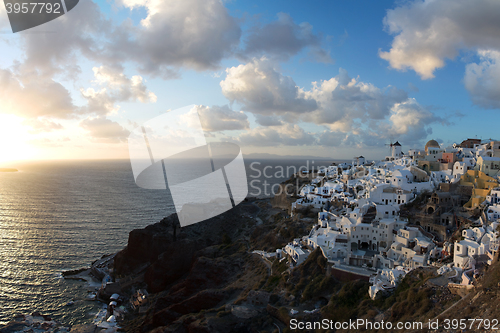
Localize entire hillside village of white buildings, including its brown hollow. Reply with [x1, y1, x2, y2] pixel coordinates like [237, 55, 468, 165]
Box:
[259, 139, 500, 299]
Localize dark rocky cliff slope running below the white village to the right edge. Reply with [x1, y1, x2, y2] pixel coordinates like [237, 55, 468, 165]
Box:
[115, 198, 500, 333]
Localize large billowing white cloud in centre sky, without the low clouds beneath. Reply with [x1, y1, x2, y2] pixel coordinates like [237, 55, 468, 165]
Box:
[220, 58, 408, 132]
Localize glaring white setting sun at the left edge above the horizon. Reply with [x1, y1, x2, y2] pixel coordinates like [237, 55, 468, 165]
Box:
[0, 114, 34, 167]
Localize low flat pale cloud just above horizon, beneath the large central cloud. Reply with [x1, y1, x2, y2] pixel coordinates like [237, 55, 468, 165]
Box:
[238, 124, 316, 147]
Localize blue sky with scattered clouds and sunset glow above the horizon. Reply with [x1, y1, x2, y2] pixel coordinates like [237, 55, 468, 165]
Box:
[0, 0, 500, 166]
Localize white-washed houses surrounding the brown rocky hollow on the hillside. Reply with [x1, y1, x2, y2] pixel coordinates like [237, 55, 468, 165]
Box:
[284, 139, 500, 297]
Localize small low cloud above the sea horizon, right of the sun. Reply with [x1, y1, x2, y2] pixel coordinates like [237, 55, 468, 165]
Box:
[80, 117, 130, 143]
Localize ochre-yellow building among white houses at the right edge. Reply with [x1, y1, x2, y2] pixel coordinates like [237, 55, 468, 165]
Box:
[459, 170, 498, 208]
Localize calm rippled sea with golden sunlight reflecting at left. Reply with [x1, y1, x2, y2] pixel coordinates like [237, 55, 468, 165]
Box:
[0, 159, 337, 326]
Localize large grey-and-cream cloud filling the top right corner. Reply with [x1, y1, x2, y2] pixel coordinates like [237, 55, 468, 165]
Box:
[380, 0, 500, 79]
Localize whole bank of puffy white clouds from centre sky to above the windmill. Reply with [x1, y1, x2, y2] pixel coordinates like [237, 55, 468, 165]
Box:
[221, 59, 438, 146]
